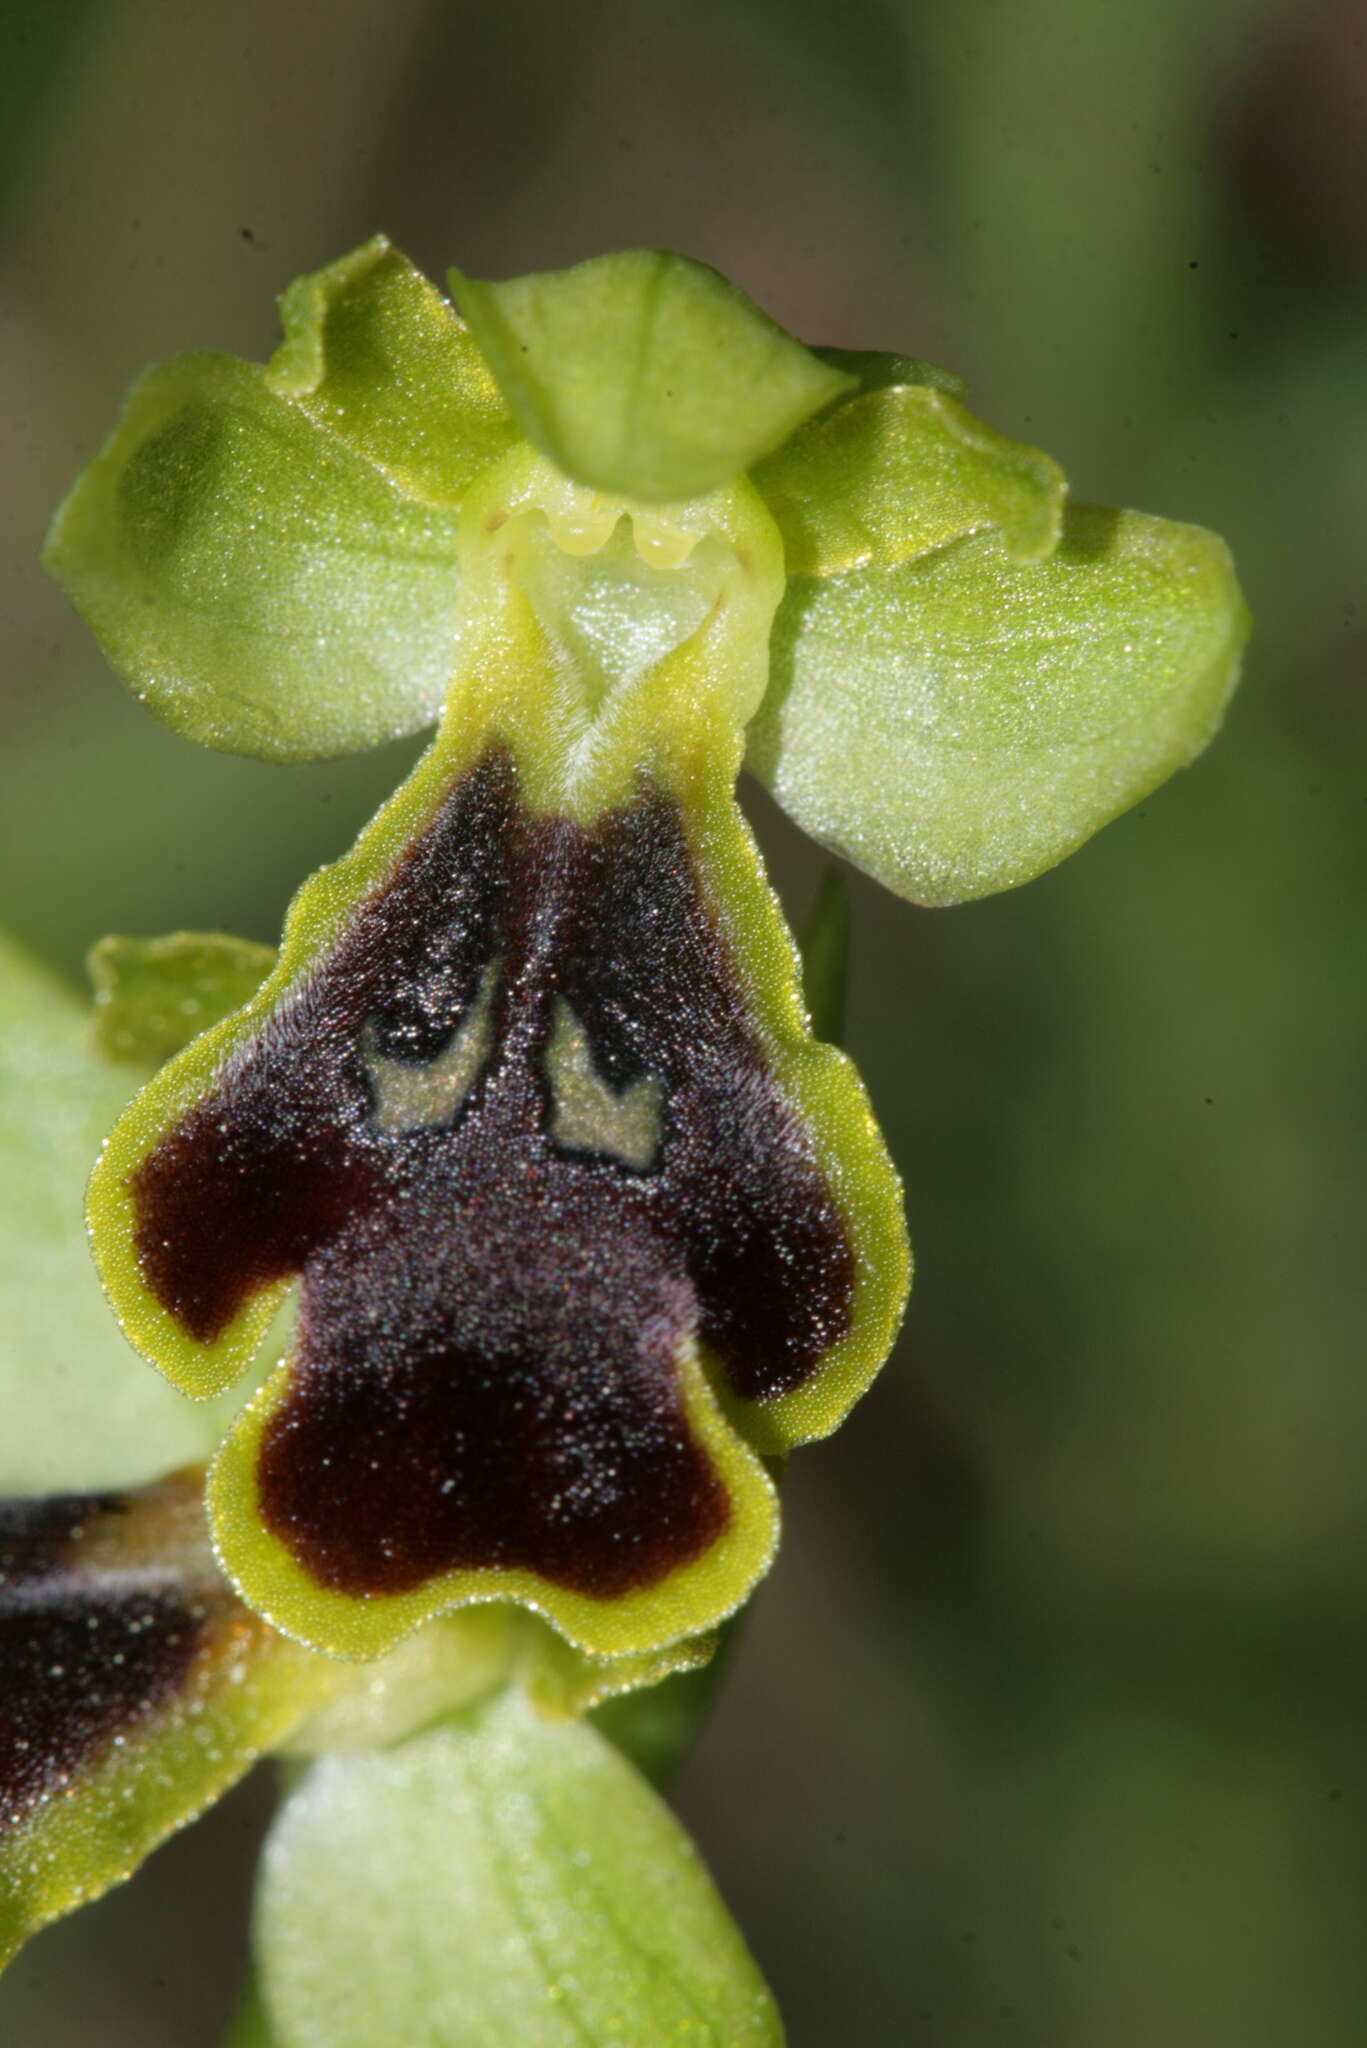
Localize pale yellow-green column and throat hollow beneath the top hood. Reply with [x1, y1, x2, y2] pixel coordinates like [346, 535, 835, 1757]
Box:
[453, 446, 783, 823]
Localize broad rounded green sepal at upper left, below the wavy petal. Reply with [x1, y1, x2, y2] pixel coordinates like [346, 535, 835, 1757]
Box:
[43, 354, 457, 760]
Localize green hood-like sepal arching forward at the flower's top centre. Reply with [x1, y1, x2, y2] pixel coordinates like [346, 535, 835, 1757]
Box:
[451, 250, 853, 500]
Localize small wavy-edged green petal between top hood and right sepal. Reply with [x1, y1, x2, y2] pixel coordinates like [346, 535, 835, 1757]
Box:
[754, 383, 1066, 575]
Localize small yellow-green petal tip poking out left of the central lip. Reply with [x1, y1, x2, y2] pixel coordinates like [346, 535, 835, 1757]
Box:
[86, 932, 275, 1065]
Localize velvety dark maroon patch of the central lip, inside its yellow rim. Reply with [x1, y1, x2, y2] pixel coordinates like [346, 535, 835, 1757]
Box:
[131, 748, 853, 1597]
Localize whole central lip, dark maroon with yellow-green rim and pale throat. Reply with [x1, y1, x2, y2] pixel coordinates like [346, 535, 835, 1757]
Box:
[90, 471, 908, 1659]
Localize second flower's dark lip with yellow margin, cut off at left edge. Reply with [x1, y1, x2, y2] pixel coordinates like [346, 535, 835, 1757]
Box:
[0, 1468, 348, 1962]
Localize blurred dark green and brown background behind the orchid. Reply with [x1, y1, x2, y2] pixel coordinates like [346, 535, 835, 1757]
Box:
[0, 0, 1367, 2048]
